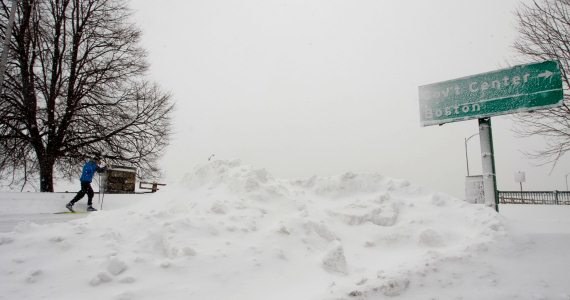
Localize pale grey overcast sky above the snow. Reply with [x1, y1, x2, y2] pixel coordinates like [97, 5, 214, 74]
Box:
[130, 0, 570, 197]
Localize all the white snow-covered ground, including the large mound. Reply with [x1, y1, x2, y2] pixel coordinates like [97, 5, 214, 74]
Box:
[0, 161, 570, 300]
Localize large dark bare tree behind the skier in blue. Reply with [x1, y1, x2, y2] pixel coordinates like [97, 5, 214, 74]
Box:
[0, 0, 173, 192]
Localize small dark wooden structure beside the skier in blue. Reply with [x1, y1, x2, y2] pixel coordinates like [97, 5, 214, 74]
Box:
[101, 165, 137, 194]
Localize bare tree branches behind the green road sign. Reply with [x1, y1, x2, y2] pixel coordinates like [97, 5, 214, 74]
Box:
[514, 0, 570, 167]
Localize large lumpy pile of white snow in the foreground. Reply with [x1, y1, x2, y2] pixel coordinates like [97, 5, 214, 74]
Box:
[0, 161, 505, 300]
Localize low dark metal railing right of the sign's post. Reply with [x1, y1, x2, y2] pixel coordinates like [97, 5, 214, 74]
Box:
[499, 191, 570, 205]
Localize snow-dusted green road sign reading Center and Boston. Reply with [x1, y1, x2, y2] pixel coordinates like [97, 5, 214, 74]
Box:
[419, 61, 563, 126]
